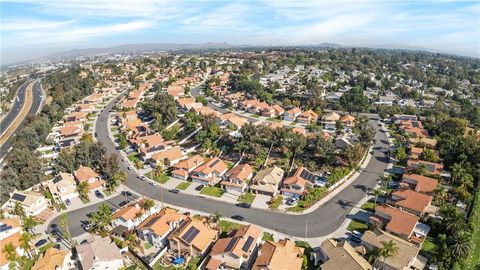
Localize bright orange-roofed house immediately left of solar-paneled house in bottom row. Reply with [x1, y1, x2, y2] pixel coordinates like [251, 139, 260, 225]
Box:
[136, 208, 187, 248]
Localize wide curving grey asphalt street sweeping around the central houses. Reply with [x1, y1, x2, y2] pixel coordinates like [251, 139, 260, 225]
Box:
[53, 87, 388, 238]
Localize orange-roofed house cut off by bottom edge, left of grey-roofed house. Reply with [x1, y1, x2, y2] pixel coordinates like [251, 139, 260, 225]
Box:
[30, 247, 75, 270]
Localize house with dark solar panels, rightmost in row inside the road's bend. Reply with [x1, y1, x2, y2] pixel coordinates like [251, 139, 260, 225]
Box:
[282, 166, 318, 197]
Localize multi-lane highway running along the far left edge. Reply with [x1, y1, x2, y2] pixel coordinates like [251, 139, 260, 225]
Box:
[0, 80, 42, 159]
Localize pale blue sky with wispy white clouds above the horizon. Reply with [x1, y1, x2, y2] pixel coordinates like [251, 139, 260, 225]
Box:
[0, 0, 480, 64]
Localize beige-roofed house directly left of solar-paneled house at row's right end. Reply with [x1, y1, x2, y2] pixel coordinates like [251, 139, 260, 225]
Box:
[249, 166, 285, 197]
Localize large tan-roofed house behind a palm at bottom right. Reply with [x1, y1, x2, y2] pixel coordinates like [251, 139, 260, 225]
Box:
[362, 230, 427, 270]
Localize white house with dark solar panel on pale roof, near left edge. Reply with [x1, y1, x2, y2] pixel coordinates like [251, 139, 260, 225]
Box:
[3, 190, 48, 216]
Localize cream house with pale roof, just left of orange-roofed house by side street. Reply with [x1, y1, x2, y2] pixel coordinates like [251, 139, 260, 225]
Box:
[46, 173, 78, 202]
